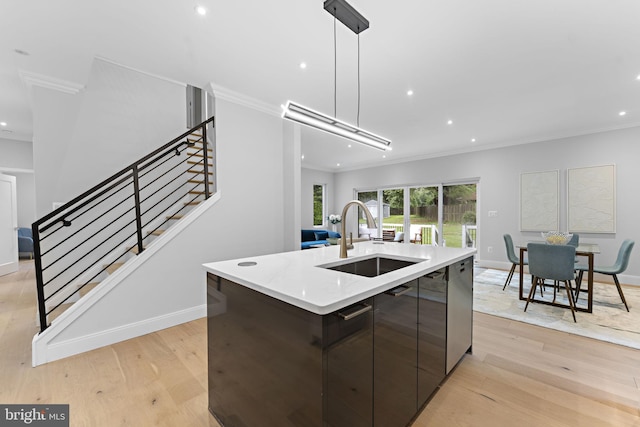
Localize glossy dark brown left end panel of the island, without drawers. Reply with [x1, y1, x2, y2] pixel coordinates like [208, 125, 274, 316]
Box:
[207, 274, 324, 427]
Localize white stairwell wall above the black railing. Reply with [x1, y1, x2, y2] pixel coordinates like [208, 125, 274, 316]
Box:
[31, 59, 186, 217]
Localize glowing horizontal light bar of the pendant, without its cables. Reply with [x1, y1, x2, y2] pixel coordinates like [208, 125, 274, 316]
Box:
[282, 101, 391, 151]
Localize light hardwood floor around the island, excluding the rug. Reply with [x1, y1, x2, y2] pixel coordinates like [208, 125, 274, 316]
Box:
[0, 261, 640, 427]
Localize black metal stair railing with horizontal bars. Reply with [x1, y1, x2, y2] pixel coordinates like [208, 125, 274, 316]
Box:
[32, 117, 215, 331]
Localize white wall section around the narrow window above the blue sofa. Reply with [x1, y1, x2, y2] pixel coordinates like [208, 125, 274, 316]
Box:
[300, 168, 338, 229]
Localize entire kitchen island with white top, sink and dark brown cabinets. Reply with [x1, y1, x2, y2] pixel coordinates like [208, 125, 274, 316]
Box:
[204, 242, 475, 427]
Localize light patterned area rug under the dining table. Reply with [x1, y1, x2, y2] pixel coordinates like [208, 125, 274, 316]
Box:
[473, 268, 640, 349]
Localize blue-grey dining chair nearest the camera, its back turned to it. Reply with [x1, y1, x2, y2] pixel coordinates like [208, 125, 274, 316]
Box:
[524, 243, 576, 322]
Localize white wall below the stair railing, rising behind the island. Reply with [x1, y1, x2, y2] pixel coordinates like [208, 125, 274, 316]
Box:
[34, 89, 288, 364]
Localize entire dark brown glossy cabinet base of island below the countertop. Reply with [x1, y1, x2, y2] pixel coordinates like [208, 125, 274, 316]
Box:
[207, 257, 473, 427]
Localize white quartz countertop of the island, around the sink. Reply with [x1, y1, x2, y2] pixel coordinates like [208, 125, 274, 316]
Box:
[203, 242, 476, 314]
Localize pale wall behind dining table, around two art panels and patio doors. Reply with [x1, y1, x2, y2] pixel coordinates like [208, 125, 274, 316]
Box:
[335, 128, 640, 284]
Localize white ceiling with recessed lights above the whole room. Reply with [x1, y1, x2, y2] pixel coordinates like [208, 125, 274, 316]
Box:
[0, 0, 640, 170]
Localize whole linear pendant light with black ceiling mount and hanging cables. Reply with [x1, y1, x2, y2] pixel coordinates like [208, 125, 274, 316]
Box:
[282, 0, 391, 151]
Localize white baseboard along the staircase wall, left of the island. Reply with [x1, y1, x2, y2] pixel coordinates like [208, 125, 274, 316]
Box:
[32, 304, 207, 367]
